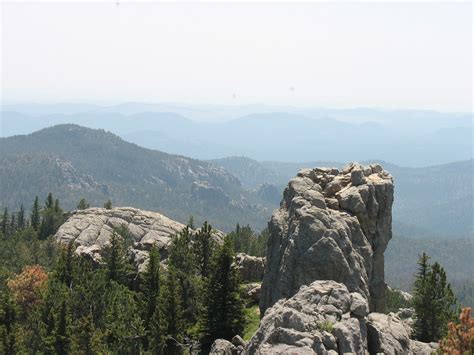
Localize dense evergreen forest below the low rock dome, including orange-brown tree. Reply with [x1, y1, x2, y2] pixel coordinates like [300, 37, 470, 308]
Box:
[0, 200, 254, 354]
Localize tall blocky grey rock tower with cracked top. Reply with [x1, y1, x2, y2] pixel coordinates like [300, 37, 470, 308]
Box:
[260, 164, 393, 314]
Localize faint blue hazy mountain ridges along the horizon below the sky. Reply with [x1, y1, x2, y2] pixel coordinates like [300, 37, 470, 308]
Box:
[0, 103, 473, 167]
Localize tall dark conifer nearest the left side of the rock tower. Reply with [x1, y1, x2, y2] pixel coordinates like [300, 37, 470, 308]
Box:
[202, 239, 245, 350]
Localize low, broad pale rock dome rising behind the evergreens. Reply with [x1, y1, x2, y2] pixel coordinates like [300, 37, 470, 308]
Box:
[55, 207, 185, 270]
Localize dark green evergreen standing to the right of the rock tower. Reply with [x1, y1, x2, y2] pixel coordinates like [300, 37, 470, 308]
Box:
[413, 253, 456, 342]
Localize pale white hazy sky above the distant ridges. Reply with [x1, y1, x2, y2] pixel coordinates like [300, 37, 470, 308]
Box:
[1, 1, 473, 111]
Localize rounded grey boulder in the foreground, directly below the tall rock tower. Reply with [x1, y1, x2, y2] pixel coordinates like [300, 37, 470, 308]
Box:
[246, 281, 369, 354]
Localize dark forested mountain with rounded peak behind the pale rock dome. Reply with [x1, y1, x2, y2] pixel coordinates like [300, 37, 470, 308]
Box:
[0, 125, 271, 230]
